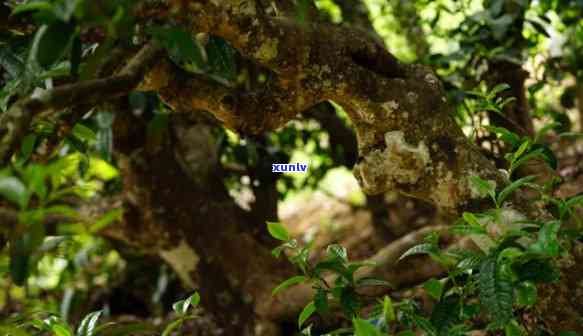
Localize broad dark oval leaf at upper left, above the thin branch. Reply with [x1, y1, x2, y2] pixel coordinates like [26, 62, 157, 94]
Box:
[31, 21, 75, 68]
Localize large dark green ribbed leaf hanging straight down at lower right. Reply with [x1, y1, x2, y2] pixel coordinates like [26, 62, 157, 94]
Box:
[478, 256, 514, 325]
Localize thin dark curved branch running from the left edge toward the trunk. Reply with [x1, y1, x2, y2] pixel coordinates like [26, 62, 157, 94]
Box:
[0, 43, 161, 162]
